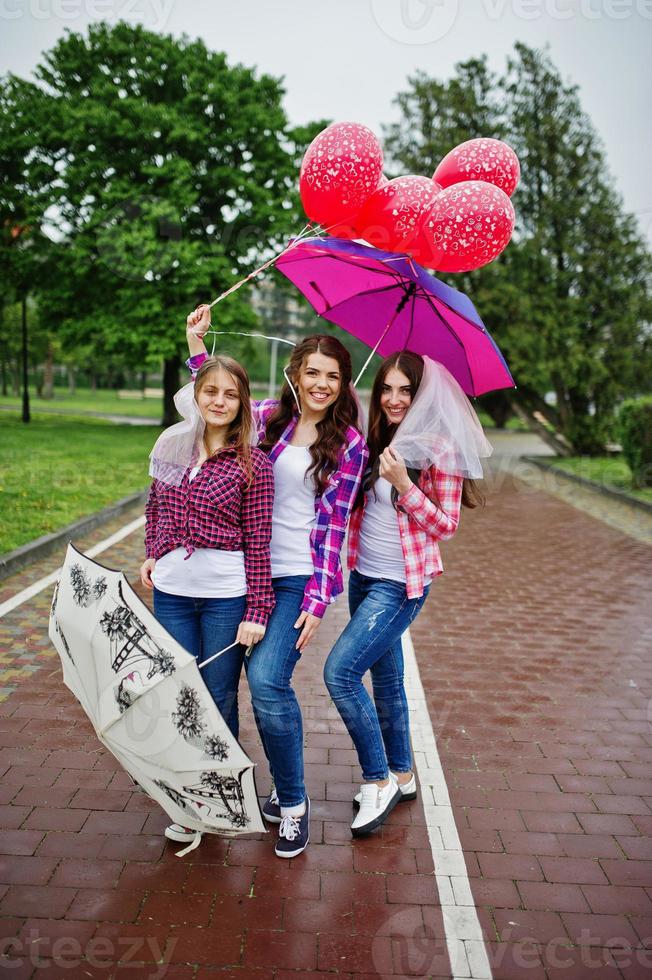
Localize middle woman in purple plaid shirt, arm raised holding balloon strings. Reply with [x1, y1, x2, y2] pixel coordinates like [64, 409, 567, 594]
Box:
[188, 307, 368, 858]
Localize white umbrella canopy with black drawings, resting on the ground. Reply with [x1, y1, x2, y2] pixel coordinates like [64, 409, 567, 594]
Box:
[50, 544, 265, 836]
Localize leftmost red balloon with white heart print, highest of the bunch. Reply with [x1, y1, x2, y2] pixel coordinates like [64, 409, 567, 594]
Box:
[299, 122, 383, 228]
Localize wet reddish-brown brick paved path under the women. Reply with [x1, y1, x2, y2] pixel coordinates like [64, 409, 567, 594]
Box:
[0, 470, 652, 980]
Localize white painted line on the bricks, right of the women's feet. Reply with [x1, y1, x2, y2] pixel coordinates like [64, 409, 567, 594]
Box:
[403, 630, 492, 980]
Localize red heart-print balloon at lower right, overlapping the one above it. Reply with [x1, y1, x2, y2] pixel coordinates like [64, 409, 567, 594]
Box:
[421, 180, 515, 272]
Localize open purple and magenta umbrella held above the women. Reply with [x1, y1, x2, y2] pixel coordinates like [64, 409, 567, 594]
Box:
[276, 238, 515, 396]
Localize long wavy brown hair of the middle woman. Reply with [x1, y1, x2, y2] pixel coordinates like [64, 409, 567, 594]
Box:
[260, 334, 358, 494]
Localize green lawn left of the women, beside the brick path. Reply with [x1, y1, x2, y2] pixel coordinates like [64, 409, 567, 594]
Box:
[0, 412, 159, 553]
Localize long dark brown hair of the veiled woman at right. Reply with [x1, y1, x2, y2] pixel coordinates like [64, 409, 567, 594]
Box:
[356, 350, 485, 509]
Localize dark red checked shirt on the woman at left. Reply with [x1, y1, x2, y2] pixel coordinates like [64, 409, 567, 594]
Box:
[145, 448, 274, 626]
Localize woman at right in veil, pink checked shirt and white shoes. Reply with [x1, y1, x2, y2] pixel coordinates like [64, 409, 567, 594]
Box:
[324, 351, 491, 836]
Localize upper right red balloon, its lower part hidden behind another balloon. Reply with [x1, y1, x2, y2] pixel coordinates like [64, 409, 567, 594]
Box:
[433, 137, 521, 197]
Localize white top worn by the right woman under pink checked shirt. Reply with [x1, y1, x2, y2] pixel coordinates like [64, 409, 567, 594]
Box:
[355, 476, 406, 582]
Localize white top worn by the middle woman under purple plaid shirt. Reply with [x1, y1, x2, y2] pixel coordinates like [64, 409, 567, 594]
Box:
[270, 445, 316, 578]
